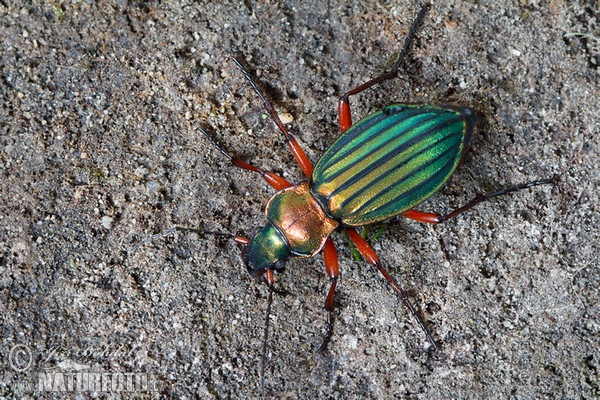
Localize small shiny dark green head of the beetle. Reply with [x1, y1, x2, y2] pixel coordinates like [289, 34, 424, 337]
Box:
[242, 223, 290, 278]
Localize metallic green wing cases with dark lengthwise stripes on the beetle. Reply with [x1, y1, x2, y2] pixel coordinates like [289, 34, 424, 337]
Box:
[311, 103, 474, 226]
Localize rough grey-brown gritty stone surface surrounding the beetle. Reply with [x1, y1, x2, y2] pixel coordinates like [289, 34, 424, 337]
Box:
[0, 0, 600, 399]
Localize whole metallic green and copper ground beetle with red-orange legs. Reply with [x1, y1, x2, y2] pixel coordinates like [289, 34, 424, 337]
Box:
[134, 2, 552, 394]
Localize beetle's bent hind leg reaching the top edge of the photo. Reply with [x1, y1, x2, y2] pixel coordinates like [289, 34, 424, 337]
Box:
[338, 4, 429, 133]
